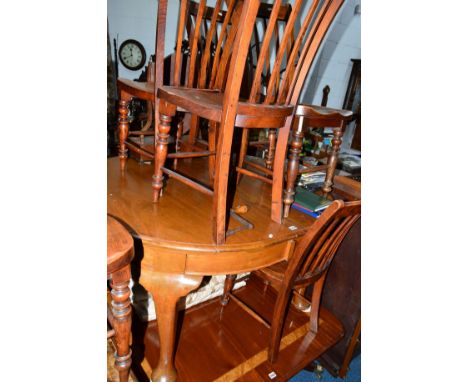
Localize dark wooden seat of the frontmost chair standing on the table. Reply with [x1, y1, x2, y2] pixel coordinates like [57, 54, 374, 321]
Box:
[158, 86, 294, 128]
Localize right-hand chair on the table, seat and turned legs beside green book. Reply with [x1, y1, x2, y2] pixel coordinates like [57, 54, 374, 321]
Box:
[284, 105, 353, 217]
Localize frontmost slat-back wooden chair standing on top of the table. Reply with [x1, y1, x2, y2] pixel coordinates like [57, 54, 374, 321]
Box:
[153, 0, 343, 244]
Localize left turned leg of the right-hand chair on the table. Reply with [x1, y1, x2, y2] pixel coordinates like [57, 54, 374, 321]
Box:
[283, 117, 304, 218]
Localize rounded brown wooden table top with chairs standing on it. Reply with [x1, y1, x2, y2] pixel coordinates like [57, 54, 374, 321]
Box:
[107, 157, 315, 252]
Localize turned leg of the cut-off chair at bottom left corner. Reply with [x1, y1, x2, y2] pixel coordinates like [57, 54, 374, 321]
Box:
[111, 265, 132, 382]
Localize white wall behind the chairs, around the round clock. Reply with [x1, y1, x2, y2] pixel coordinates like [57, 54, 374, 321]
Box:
[107, 0, 361, 108]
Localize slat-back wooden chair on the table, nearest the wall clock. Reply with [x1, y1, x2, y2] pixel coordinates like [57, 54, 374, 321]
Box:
[118, 0, 247, 184]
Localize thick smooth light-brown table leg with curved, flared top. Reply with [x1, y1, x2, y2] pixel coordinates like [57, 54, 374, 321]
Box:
[140, 273, 203, 382]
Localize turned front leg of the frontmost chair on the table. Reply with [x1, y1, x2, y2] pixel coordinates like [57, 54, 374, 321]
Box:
[152, 104, 172, 203]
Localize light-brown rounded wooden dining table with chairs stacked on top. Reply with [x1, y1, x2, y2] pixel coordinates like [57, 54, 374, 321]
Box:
[107, 157, 315, 382]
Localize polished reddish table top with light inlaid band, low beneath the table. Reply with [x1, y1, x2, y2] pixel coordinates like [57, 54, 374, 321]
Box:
[132, 278, 343, 382]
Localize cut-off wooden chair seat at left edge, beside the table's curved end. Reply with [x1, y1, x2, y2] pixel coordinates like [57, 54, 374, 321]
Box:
[107, 216, 133, 276]
